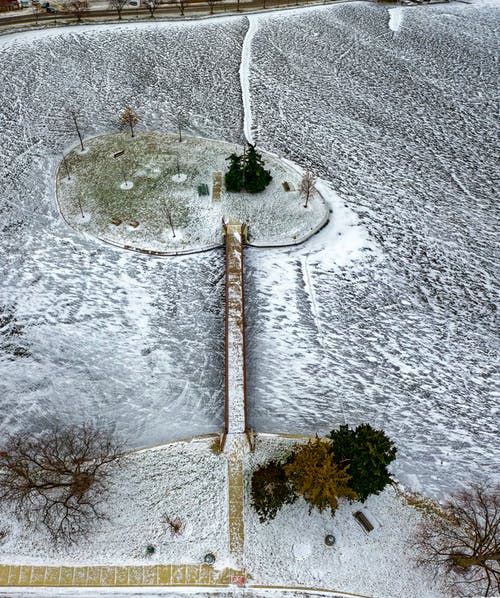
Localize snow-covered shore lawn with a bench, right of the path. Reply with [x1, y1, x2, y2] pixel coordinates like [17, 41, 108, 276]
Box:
[245, 435, 444, 598]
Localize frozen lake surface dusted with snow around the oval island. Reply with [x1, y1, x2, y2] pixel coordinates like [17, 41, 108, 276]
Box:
[0, 3, 499, 495]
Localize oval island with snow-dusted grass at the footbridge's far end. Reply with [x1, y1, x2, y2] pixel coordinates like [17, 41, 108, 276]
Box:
[57, 133, 329, 255]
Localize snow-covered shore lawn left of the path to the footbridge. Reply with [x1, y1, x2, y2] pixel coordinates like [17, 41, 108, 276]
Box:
[0, 438, 228, 566]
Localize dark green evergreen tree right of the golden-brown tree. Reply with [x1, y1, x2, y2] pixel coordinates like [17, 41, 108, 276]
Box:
[329, 424, 396, 502]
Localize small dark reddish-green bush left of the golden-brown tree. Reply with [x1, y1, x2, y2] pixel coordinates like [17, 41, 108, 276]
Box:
[251, 461, 297, 523]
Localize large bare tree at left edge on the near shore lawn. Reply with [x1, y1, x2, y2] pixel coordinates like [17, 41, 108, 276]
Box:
[0, 425, 119, 543]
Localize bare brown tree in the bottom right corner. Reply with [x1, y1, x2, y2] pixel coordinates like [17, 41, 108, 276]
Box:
[415, 482, 500, 596]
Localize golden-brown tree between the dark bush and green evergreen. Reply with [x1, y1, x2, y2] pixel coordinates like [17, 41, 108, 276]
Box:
[284, 438, 357, 515]
